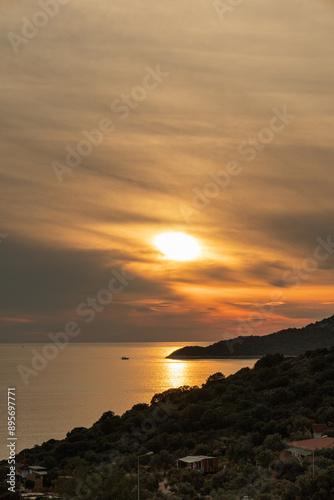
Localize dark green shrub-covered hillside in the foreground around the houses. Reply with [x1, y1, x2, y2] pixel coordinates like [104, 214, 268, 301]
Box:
[0, 348, 334, 500]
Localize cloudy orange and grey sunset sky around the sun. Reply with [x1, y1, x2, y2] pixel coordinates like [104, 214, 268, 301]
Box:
[0, 0, 334, 342]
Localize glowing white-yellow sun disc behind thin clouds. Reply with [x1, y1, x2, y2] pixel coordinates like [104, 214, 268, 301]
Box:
[154, 233, 201, 261]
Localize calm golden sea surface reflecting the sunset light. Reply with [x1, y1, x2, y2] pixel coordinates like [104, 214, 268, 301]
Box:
[0, 342, 256, 459]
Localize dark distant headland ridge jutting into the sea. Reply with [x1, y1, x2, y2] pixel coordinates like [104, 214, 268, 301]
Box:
[166, 315, 334, 359]
